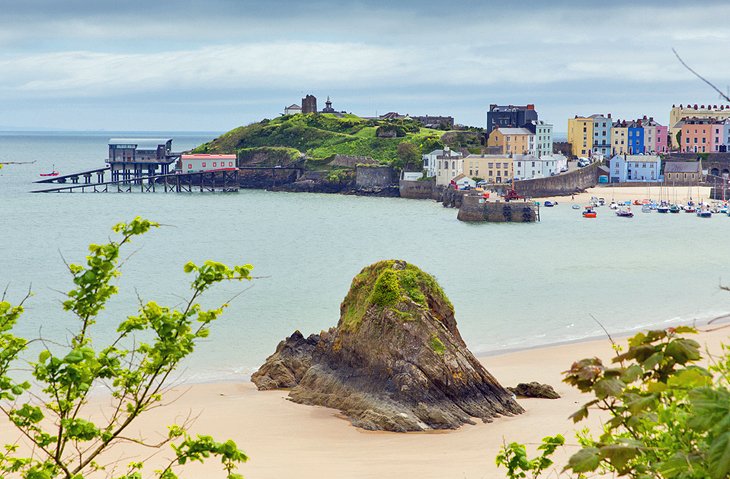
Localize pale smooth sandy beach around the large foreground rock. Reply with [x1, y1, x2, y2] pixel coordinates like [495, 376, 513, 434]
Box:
[0, 328, 730, 479]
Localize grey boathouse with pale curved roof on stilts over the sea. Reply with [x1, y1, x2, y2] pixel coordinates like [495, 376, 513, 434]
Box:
[107, 138, 179, 181]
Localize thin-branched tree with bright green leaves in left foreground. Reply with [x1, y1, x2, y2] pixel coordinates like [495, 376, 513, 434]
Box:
[0, 218, 252, 479]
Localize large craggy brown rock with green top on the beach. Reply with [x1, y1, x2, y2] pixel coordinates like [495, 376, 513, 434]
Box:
[252, 260, 523, 432]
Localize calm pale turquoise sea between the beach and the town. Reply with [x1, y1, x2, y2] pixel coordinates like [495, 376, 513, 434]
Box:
[0, 133, 730, 381]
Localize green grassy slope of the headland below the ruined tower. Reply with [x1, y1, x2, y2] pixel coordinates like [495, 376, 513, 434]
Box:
[194, 113, 444, 166]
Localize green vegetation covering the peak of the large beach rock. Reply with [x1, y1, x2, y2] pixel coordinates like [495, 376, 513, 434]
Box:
[341, 260, 453, 329]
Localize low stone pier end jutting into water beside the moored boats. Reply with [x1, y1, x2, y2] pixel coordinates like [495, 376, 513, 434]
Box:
[457, 195, 538, 223]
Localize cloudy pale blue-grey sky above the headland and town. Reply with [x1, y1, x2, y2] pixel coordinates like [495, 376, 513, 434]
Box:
[0, 0, 730, 131]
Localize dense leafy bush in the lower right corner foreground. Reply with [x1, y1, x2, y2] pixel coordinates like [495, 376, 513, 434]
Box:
[565, 327, 730, 479]
